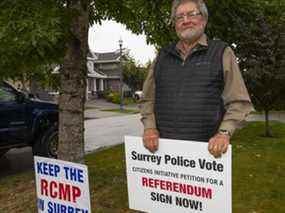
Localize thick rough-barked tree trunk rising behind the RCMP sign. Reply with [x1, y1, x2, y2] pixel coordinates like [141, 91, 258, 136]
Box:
[58, 0, 89, 163]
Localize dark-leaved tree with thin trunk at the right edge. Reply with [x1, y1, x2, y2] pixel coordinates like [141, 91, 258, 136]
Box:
[239, 2, 285, 136]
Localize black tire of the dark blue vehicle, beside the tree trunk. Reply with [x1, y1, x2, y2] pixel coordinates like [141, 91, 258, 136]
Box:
[33, 125, 58, 158]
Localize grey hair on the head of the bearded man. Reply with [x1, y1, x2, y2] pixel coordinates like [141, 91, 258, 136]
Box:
[170, 0, 209, 23]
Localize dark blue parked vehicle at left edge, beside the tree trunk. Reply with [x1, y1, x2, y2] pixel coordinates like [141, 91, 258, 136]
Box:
[0, 81, 58, 158]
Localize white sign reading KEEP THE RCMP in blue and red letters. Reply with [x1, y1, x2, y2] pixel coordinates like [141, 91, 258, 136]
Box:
[34, 156, 91, 213]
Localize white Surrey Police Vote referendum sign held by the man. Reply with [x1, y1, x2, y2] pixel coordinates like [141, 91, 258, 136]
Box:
[125, 136, 232, 213]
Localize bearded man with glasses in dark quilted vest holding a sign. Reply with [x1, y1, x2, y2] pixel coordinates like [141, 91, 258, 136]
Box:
[141, 0, 253, 157]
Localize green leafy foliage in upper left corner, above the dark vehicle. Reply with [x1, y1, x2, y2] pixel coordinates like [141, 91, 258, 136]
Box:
[0, 0, 68, 80]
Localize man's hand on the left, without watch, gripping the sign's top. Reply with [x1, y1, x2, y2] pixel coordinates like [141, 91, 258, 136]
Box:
[143, 129, 159, 153]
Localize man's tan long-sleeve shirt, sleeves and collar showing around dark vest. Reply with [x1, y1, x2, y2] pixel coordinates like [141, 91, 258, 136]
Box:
[141, 35, 253, 135]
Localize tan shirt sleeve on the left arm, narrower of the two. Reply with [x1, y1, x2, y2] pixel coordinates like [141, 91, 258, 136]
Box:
[140, 59, 156, 130]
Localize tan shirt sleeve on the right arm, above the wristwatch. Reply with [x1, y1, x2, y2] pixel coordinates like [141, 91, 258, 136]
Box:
[219, 47, 254, 135]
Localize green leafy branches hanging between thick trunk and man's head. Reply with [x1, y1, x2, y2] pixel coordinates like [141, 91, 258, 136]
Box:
[94, 0, 173, 47]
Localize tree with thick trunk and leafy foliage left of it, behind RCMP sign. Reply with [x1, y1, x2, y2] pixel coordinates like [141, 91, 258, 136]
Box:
[0, 0, 90, 162]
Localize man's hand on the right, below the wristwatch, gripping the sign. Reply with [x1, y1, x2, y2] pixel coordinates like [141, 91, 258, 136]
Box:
[208, 133, 230, 158]
